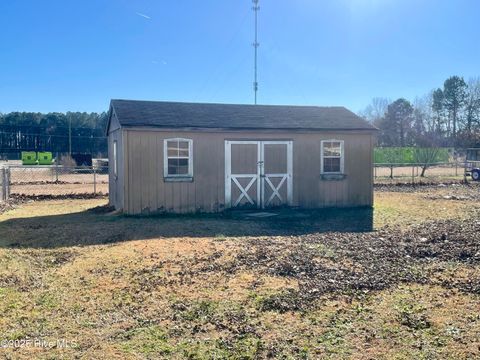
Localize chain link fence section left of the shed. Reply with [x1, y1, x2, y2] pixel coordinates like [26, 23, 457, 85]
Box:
[0, 165, 108, 200]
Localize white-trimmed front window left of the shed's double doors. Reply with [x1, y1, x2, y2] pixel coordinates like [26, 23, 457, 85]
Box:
[163, 138, 193, 177]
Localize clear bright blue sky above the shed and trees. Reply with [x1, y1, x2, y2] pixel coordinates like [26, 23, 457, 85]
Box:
[0, 0, 480, 112]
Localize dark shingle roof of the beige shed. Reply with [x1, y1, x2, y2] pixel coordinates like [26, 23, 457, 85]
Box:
[111, 100, 376, 131]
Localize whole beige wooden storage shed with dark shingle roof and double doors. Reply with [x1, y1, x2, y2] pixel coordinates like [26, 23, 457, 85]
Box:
[107, 100, 377, 214]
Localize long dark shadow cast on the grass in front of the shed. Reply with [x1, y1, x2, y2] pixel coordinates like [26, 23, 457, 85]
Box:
[0, 207, 373, 248]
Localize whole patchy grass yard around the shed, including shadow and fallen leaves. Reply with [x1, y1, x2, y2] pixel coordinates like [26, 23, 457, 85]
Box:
[0, 186, 480, 359]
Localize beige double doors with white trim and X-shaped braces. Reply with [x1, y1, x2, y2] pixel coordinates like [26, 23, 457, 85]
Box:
[225, 141, 293, 208]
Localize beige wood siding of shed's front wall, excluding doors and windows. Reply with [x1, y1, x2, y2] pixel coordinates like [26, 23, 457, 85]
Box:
[120, 129, 373, 214]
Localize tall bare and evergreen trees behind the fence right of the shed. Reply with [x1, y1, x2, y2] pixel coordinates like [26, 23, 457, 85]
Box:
[360, 76, 480, 149]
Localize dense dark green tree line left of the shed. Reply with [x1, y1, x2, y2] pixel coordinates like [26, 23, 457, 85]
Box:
[0, 112, 108, 159]
